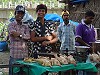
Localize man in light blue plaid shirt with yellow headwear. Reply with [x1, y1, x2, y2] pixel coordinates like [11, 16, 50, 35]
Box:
[57, 10, 75, 54]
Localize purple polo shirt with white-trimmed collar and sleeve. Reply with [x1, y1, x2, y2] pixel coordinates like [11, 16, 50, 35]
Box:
[76, 23, 95, 45]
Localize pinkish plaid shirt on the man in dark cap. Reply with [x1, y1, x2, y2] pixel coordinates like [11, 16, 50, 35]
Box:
[8, 21, 30, 59]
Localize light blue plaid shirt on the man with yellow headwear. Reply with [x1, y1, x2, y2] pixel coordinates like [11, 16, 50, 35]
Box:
[57, 22, 75, 50]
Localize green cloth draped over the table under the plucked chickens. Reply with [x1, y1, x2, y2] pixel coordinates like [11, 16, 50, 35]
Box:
[13, 61, 98, 75]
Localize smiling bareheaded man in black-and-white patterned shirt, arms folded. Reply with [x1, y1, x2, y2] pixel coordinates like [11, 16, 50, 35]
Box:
[31, 4, 57, 53]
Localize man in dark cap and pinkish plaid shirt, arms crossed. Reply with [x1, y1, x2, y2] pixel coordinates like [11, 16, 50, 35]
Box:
[8, 5, 30, 75]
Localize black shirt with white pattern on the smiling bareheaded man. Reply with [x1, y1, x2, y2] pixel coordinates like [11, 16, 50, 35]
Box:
[30, 18, 55, 52]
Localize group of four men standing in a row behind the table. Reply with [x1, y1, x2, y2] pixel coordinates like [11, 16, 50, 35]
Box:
[8, 4, 95, 75]
